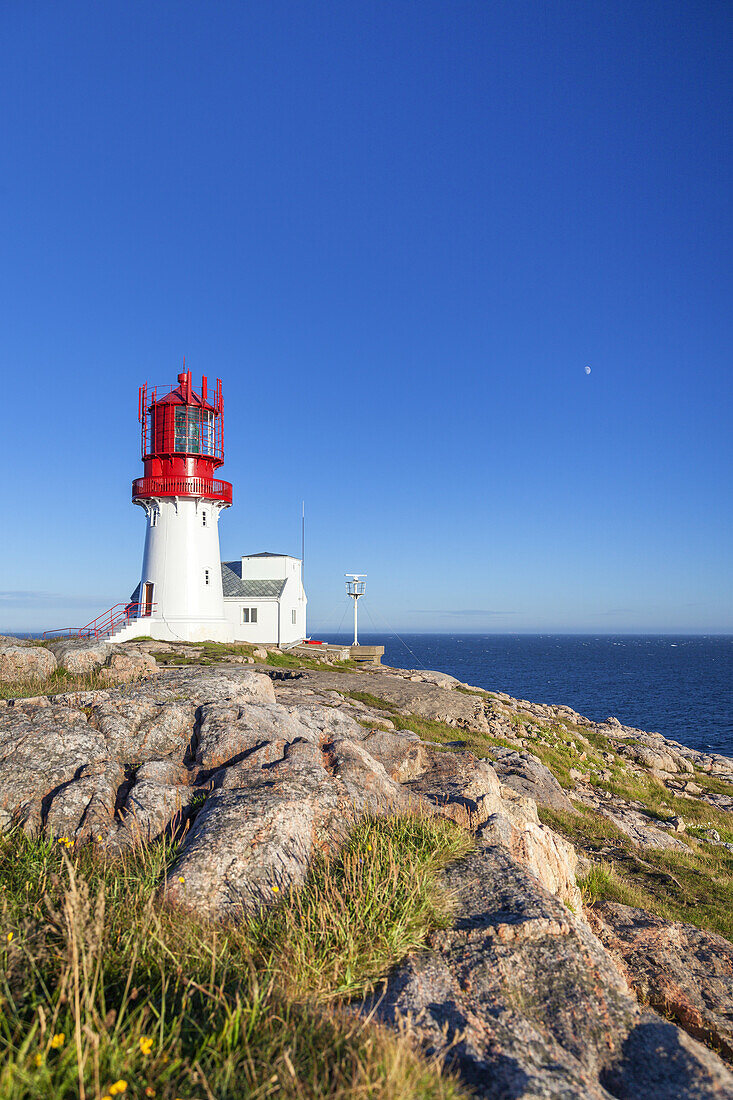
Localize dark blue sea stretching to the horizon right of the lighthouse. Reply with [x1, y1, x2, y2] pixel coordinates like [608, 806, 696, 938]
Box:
[318, 634, 733, 756]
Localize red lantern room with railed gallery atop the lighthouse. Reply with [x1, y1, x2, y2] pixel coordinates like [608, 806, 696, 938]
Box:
[132, 371, 232, 506]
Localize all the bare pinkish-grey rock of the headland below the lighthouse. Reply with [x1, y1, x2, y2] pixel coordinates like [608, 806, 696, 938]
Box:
[0, 645, 733, 1100]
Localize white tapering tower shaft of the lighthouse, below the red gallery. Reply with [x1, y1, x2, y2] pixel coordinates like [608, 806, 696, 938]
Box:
[135, 497, 231, 641]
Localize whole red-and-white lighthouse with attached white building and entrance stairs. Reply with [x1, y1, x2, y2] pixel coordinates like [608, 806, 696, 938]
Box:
[46, 371, 308, 647]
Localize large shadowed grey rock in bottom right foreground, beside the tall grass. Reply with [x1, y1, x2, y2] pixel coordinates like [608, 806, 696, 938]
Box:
[363, 845, 733, 1100]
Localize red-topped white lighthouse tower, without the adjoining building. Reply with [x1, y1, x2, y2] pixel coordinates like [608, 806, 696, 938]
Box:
[116, 371, 233, 641]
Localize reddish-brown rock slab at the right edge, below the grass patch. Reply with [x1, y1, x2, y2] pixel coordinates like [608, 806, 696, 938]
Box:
[588, 902, 733, 1060]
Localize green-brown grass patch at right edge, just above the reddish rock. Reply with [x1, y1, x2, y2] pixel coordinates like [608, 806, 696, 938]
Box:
[538, 803, 733, 941]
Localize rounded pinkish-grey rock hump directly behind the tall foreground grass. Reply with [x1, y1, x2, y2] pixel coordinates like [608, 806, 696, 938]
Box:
[167, 721, 413, 920]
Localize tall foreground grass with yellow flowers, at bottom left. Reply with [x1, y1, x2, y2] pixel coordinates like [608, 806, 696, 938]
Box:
[0, 818, 470, 1100]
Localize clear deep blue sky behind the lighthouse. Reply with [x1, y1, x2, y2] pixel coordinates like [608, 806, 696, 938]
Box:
[0, 0, 733, 633]
